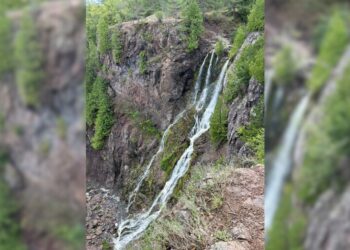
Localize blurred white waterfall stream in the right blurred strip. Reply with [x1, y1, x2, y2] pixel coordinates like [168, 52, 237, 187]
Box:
[265, 95, 310, 232]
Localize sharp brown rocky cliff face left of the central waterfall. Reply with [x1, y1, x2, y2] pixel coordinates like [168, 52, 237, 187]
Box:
[87, 16, 234, 191]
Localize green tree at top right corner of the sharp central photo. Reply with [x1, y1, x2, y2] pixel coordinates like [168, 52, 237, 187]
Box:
[247, 0, 265, 32]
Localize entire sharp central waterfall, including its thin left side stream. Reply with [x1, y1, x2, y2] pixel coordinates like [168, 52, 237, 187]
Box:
[113, 55, 229, 250]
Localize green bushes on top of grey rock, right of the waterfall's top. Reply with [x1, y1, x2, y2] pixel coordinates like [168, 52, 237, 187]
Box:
[224, 37, 264, 103]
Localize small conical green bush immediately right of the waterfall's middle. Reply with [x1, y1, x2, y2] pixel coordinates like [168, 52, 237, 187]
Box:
[210, 96, 228, 144]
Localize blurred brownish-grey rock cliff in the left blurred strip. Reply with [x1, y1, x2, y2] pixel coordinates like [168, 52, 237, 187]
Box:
[0, 1, 85, 249]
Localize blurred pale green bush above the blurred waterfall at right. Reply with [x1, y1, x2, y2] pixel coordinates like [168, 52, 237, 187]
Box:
[273, 46, 297, 85]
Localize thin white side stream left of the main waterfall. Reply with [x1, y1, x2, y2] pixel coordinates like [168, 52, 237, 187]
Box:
[126, 109, 187, 213]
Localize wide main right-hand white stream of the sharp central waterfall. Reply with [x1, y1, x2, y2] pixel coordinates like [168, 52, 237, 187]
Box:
[113, 59, 229, 250]
